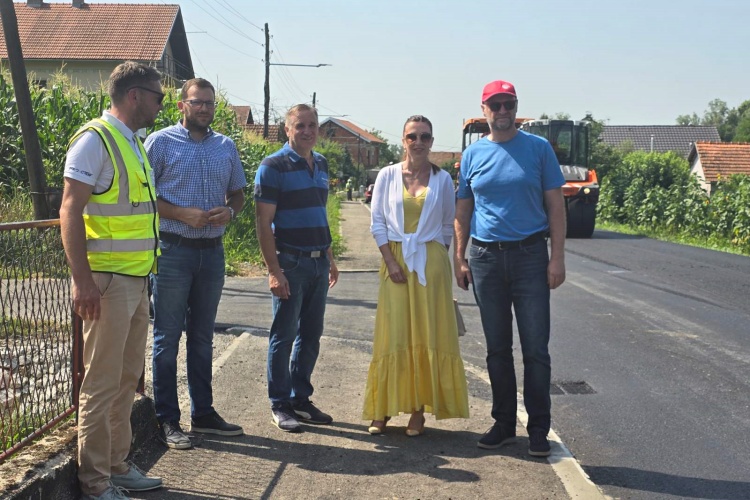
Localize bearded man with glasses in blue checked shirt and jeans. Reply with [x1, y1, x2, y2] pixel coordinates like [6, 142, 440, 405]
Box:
[145, 78, 247, 450]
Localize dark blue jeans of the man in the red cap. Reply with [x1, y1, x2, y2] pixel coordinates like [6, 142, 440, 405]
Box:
[469, 240, 552, 434]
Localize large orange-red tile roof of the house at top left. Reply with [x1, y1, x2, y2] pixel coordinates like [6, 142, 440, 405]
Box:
[0, 3, 180, 61]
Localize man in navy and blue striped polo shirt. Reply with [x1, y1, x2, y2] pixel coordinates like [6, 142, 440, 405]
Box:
[255, 104, 339, 432]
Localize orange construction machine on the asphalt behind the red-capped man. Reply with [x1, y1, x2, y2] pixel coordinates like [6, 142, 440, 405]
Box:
[462, 118, 599, 238]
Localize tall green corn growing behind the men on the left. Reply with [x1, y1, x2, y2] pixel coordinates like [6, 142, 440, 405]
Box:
[0, 73, 344, 266]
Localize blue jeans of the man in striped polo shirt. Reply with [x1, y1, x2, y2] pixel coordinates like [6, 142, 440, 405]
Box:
[268, 253, 331, 407]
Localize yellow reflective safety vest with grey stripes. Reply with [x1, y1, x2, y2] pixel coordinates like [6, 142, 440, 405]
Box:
[70, 118, 160, 276]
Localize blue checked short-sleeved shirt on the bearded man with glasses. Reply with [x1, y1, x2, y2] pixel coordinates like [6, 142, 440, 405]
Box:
[144, 123, 247, 238]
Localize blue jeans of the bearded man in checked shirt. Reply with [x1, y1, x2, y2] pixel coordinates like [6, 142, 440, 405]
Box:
[151, 242, 224, 422]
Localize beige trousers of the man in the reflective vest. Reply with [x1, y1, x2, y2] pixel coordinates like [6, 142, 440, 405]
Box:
[78, 273, 148, 495]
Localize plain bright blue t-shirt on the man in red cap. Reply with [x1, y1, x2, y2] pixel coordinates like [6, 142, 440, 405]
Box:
[458, 130, 565, 241]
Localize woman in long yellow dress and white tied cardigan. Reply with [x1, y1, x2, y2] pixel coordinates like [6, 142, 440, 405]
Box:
[362, 115, 469, 436]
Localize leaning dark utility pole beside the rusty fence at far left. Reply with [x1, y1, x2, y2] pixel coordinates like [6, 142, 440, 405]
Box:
[0, 0, 49, 220]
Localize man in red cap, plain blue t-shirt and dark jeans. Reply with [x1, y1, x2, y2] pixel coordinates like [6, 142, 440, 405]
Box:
[454, 80, 565, 457]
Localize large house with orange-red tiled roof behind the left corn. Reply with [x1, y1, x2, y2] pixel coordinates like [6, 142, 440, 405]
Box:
[0, 0, 195, 89]
